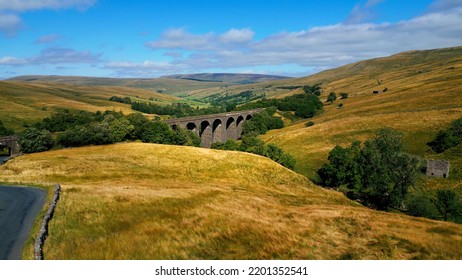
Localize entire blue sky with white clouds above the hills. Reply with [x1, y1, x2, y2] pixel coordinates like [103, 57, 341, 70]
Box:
[0, 0, 462, 78]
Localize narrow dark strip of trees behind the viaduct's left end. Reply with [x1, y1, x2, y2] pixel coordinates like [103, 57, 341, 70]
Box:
[131, 102, 227, 118]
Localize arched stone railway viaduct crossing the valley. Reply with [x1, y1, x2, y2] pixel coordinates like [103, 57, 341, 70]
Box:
[166, 109, 264, 148]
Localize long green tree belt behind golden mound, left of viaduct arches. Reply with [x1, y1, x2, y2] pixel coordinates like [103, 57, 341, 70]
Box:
[20, 110, 200, 153]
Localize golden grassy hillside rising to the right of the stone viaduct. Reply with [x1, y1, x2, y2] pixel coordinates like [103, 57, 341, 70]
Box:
[263, 48, 462, 185]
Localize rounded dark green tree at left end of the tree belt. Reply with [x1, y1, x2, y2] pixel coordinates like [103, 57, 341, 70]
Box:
[19, 128, 53, 153]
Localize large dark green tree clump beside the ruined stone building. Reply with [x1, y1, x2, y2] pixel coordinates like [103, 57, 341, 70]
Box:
[318, 129, 419, 210]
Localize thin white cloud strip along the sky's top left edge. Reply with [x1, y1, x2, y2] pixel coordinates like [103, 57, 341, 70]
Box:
[0, 0, 96, 12]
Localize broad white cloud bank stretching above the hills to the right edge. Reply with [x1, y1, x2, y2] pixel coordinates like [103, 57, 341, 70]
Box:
[129, 4, 462, 77]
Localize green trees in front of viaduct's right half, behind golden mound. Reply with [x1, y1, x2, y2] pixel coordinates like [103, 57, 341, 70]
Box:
[212, 136, 296, 170]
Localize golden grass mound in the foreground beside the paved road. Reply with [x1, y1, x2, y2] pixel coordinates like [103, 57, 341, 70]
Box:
[0, 143, 462, 259]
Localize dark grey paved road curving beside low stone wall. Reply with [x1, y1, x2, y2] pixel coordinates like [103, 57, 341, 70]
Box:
[0, 186, 46, 260]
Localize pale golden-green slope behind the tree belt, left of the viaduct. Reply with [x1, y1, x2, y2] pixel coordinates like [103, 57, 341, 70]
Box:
[0, 81, 178, 130]
